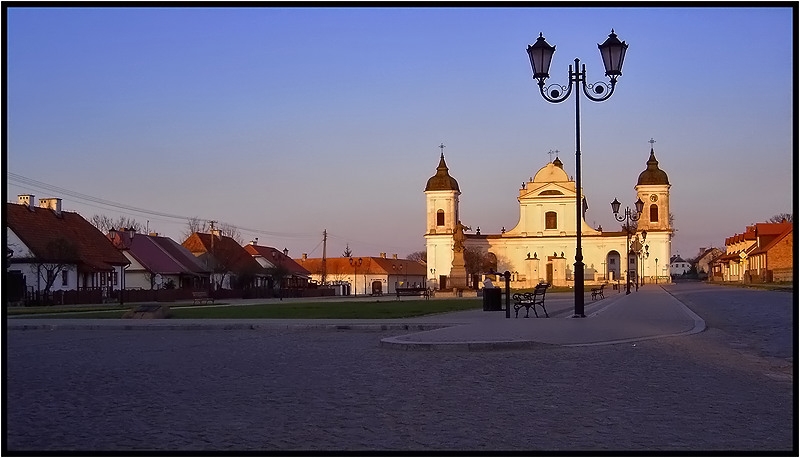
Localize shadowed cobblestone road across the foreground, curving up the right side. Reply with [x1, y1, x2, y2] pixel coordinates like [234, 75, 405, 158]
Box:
[4, 285, 797, 453]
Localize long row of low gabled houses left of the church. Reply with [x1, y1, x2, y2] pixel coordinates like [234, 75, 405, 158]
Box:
[5, 195, 426, 303]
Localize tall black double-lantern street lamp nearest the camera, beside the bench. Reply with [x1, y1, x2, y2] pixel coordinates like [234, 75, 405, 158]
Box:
[528, 29, 628, 318]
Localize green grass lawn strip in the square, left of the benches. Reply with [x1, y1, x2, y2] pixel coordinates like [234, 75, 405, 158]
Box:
[9, 298, 483, 319]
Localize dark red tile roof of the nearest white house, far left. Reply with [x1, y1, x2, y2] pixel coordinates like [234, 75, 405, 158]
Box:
[5, 203, 130, 271]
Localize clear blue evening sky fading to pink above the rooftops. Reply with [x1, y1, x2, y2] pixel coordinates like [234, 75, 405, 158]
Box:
[3, 3, 797, 258]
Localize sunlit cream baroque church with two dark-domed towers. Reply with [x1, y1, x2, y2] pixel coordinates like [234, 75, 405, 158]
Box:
[425, 143, 673, 290]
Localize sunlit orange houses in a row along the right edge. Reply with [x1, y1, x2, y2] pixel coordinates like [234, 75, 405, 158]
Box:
[709, 220, 794, 283]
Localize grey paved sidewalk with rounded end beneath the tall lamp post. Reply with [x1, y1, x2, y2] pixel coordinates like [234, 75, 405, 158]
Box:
[6, 285, 705, 351]
